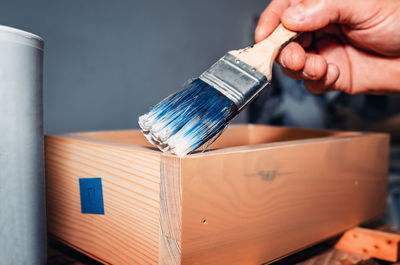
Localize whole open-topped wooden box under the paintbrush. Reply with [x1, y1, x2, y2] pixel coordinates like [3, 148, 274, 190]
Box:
[46, 125, 389, 265]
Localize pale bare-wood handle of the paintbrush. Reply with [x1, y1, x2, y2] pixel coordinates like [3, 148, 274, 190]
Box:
[229, 24, 297, 81]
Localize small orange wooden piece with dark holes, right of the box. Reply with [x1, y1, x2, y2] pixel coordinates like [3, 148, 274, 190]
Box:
[335, 227, 400, 262]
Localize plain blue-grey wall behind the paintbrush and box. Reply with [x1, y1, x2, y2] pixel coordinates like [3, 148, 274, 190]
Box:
[0, 0, 267, 133]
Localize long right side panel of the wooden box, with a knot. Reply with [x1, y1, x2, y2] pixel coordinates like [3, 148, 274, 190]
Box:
[181, 135, 389, 265]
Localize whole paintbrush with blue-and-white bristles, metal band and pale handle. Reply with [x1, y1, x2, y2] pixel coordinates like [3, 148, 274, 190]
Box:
[139, 25, 297, 156]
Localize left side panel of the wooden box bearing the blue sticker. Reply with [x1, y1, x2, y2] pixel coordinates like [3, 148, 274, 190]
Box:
[46, 136, 160, 264]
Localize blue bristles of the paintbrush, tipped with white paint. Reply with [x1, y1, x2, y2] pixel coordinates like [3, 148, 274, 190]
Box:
[139, 79, 238, 156]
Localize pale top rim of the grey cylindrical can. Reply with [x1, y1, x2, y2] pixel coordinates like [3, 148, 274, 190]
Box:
[0, 25, 44, 50]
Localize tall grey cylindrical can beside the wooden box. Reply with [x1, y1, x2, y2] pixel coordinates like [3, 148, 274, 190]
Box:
[0, 26, 46, 265]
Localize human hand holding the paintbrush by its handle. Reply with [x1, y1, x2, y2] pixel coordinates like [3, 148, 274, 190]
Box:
[255, 0, 400, 94]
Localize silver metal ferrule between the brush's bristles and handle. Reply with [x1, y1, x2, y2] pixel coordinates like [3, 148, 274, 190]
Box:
[200, 53, 268, 111]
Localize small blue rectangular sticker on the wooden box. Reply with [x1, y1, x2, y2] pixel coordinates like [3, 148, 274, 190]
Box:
[79, 178, 104, 214]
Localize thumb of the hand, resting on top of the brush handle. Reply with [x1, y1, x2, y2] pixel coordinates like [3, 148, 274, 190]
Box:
[281, 0, 379, 31]
